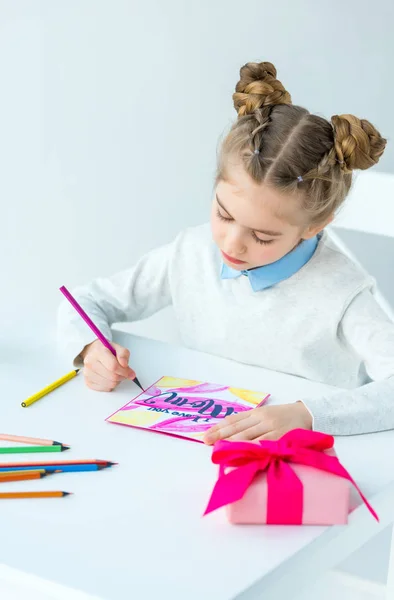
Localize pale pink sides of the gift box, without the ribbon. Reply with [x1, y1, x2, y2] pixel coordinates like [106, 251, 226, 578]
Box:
[226, 450, 351, 525]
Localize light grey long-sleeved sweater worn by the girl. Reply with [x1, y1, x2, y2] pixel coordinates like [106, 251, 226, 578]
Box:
[58, 225, 394, 435]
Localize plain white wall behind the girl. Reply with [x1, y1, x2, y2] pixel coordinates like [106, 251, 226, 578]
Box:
[0, 0, 394, 592]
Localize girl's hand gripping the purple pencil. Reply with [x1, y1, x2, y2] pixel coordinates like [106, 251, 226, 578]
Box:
[81, 340, 135, 392]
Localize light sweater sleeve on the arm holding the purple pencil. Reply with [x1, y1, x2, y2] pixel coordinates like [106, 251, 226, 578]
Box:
[57, 241, 176, 367]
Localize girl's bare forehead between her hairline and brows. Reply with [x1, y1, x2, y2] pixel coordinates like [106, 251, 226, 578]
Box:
[216, 167, 302, 229]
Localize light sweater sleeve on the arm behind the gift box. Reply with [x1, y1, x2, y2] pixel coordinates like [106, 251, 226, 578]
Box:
[302, 290, 394, 435]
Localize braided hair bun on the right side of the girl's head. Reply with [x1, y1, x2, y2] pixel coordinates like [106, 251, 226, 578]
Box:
[331, 115, 387, 173]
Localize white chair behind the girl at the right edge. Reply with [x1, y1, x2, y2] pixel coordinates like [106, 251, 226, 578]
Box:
[329, 171, 394, 600]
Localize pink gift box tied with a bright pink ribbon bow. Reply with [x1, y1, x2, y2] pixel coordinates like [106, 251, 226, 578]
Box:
[204, 429, 378, 525]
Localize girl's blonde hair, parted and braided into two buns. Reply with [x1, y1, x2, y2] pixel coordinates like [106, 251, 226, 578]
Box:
[215, 62, 386, 224]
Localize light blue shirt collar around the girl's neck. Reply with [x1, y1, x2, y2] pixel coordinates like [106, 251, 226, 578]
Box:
[221, 236, 319, 292]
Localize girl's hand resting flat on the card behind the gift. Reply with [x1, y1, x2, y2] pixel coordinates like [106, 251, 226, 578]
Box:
[204, 402, 312, 445]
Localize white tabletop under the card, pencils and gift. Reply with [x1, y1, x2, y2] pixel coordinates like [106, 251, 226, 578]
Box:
[0, 332, 394, 600]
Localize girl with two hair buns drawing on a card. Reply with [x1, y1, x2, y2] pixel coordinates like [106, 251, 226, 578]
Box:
[58, 62, 394, 444]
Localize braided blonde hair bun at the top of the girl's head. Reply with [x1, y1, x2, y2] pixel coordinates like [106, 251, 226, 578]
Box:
[233, 62, 291, 117]
